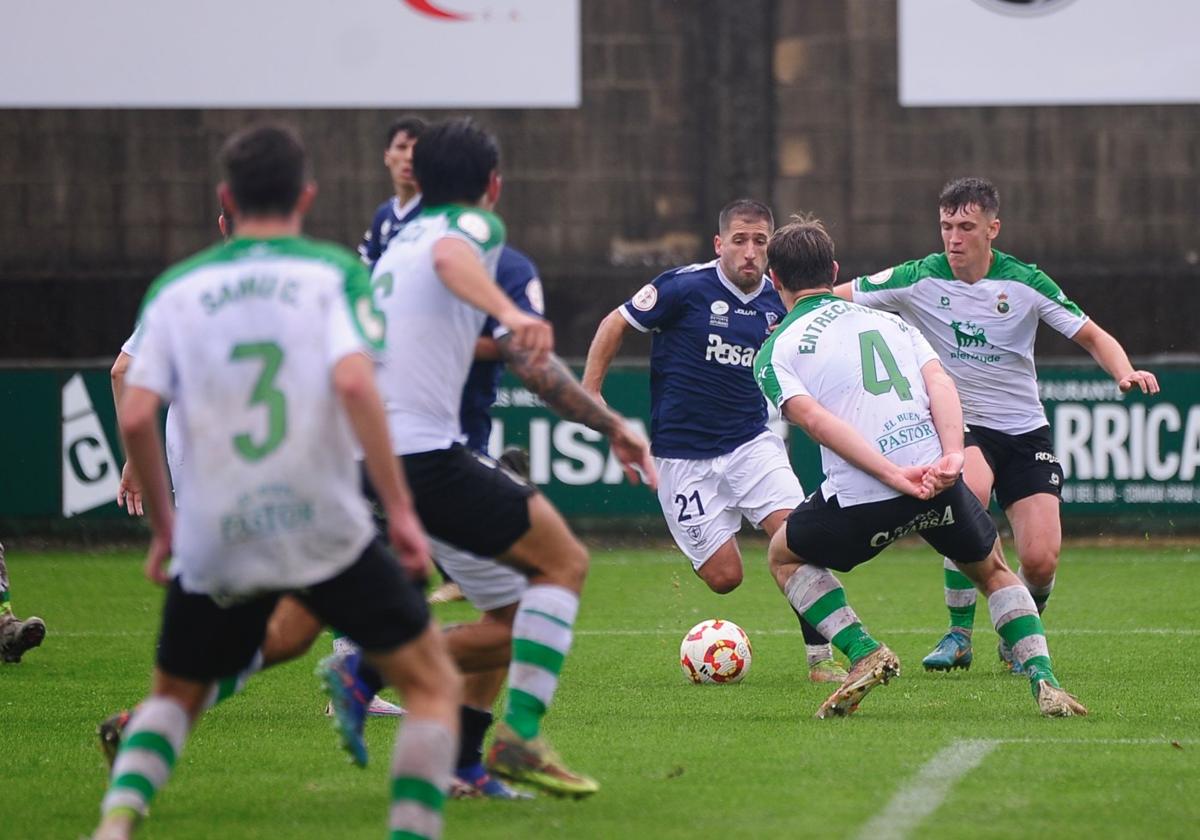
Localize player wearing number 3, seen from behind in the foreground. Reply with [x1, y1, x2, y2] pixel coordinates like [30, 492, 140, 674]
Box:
[94, 126, 461, 840]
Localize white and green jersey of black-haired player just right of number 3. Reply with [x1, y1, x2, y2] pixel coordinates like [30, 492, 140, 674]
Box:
[371, 204, 504, 455]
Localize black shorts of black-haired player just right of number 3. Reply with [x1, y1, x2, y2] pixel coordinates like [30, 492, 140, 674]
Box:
[379, 444, 538, 557]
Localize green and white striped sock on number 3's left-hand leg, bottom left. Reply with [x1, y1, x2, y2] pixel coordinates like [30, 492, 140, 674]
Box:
[101, 697, 191, 814]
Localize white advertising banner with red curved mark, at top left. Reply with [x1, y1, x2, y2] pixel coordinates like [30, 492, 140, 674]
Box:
[0, 0, 580, 108]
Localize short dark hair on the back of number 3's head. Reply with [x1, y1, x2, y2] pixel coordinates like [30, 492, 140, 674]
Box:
[221, 125, 308, 217]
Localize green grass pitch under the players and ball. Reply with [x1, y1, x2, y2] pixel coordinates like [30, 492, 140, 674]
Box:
[0, 544, 1200, 840]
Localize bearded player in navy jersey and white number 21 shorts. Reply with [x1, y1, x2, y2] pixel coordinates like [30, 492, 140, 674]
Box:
[583, 199, 846, 683]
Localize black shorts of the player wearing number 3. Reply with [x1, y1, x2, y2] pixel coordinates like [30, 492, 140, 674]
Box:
[156, 540, 430, 683]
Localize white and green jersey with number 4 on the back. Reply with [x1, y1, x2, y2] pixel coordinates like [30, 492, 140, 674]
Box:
[754, 294, 942, 508]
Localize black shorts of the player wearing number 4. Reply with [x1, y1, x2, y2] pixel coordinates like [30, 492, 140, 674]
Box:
[787, 480, 996, 571]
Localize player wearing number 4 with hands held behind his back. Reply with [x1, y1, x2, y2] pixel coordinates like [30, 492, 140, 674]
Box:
[754, 214, 1087, 718]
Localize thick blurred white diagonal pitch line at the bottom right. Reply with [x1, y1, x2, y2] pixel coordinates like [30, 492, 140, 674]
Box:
[858, 740, 1000, 840]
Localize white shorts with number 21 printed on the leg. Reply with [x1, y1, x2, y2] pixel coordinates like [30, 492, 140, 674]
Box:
[654, 432, 804, 569]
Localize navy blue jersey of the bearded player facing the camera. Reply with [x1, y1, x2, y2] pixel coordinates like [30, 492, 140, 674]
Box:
[619, 259, 786, 458]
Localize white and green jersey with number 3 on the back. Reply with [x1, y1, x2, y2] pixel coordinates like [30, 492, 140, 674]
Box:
[127, 236, 383, 601]
